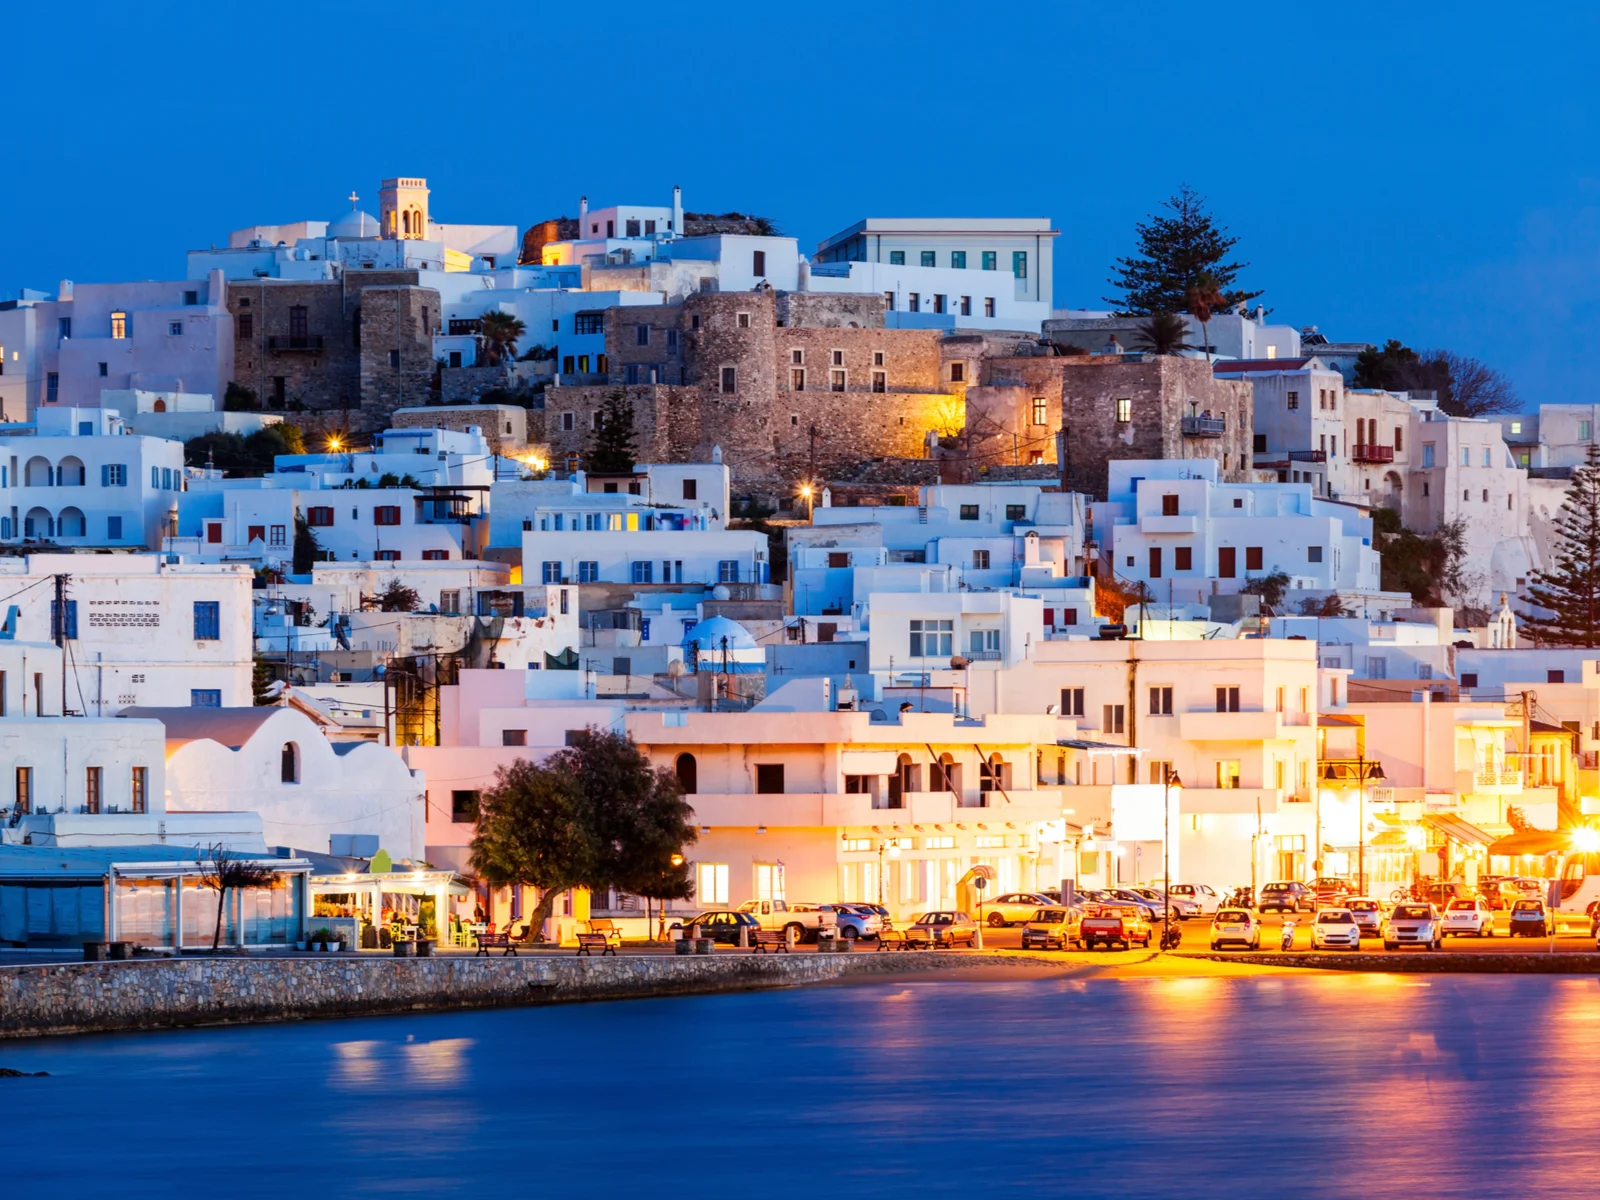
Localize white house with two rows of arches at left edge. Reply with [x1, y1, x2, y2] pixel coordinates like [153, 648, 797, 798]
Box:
[0, 408, 184, 549]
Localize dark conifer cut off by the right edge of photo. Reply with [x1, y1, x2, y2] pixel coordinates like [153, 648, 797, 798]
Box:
[1520, 442, 1600, 648]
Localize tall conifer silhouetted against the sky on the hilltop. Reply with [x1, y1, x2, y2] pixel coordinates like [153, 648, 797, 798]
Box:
[1106, 184, 1261, 317]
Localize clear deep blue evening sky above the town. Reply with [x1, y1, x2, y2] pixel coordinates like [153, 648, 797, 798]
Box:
[0, 0, 1600, 406]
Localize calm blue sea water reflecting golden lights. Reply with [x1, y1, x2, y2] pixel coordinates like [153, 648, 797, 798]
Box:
[0, 974, 1600, 1200]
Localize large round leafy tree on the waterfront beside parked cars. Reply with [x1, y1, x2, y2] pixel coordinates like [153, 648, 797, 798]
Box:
[472, 730, 696, 930]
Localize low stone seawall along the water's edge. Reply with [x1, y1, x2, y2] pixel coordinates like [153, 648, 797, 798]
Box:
[0, 950, 1064, 1038]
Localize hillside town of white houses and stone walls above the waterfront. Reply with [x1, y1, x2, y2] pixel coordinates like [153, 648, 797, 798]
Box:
[0, 176, 1600, 954]
